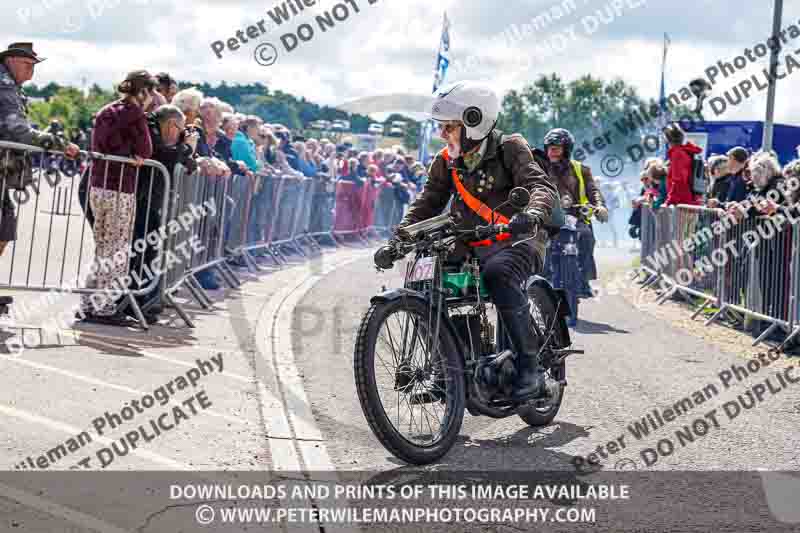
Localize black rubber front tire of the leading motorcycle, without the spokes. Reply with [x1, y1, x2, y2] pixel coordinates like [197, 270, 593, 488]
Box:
[353, 298, 466, 465]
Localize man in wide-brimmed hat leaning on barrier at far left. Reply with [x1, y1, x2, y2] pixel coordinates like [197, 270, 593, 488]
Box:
[0, 43, 80, 311]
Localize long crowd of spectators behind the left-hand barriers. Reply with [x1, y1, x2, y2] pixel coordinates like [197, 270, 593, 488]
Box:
[0, 47, 426, 325]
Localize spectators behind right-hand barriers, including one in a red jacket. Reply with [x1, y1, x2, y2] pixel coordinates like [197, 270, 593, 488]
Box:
[629, 119, 800, 342]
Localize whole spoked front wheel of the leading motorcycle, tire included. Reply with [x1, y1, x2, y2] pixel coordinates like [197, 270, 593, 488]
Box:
[353, 298, 465, 465]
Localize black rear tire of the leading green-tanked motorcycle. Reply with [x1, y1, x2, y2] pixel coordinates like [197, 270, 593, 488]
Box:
[519, 285, 565, 427]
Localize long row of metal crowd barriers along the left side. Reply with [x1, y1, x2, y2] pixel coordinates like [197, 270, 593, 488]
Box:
[0, 142, 410, 336]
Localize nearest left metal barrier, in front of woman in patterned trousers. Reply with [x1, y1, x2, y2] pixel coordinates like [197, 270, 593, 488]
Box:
[0, 141, 170, 327]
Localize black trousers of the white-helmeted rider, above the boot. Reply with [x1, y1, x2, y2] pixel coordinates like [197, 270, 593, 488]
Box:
[481, 243, 541, 309]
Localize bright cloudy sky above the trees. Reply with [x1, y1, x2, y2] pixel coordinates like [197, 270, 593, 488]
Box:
[0, 0, 800, 124]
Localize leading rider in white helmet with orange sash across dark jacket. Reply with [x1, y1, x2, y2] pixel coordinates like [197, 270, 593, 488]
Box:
[375, 82, 558, 401]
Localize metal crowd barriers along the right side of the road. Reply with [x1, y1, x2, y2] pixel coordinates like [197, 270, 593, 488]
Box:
[637, 205, 800, 348]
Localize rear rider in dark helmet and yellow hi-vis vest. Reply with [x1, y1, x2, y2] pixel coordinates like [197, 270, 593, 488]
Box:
[544, 128, 608, 297]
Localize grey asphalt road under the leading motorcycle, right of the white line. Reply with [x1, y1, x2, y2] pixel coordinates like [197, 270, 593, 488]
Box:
[294, 249, 800, 470]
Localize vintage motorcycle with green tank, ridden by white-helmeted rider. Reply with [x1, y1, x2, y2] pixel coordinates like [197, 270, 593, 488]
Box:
[354, 187, 583, 465]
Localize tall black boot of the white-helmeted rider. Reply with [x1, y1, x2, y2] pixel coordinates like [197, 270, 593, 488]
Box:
[498, 305, 545, 402]
